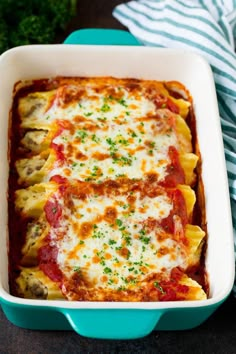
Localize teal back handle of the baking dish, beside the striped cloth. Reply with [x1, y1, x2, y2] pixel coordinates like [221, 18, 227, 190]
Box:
[64, 28, 141, 46]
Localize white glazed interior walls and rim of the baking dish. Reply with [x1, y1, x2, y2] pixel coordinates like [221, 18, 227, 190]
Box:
[0, 45, 234, 308]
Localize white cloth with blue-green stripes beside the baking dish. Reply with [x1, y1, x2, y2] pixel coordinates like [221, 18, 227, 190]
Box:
[113, 0, 236, 296]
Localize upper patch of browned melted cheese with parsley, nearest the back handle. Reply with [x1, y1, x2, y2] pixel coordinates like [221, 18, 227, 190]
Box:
[18, 82, 191, 182]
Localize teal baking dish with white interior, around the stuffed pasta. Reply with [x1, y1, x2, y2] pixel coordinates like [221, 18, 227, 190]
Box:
[0, 37, 234, 339]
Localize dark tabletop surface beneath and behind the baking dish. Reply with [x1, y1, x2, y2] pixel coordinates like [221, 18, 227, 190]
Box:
[0, 0, 236, 354]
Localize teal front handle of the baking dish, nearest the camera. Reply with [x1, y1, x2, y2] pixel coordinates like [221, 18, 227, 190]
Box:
[59, 308, 165, 339]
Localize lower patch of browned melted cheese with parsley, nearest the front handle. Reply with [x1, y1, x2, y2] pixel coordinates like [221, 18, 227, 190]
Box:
[51, 189, 187, 289]
